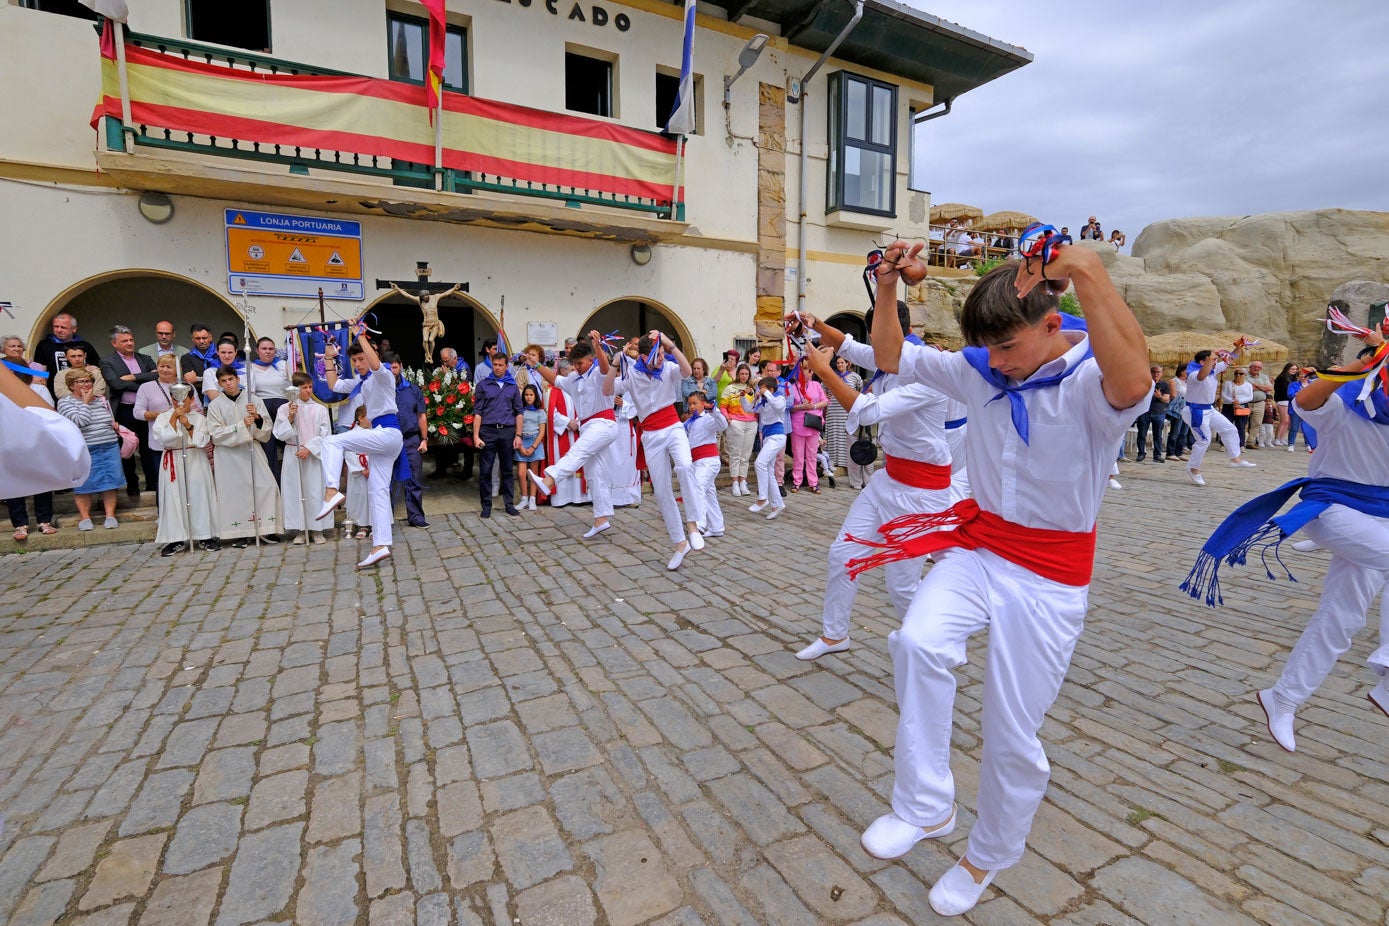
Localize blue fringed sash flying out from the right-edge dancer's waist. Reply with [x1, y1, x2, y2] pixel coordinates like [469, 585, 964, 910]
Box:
[1181, 476, 1389, 608]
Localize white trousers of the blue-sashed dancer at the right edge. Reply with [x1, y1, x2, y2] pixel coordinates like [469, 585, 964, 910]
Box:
[1274, 505, 1389, 708]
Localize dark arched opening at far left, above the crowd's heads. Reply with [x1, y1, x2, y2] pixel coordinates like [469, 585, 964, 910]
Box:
[31, 271, 247, 357]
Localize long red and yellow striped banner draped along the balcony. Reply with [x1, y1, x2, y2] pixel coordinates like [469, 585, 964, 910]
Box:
[92, 43, 675, 203]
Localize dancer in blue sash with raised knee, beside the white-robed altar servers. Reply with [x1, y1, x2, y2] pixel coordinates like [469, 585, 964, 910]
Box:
[314, 326, 410, 569]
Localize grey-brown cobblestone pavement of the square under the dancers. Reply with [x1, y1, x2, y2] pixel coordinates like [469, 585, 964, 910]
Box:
[0, 453, 1389, 926]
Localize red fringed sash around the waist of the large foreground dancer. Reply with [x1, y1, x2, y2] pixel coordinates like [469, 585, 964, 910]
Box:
[845, 498, 1095, 587]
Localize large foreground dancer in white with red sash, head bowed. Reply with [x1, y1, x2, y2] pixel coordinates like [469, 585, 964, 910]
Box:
[849, 242, 1153, 916]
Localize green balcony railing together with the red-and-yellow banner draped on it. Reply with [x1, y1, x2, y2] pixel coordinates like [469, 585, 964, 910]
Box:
[93, 24, 685, 221]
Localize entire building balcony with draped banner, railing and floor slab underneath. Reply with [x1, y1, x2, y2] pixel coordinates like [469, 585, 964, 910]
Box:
[93, 31, 688, 243]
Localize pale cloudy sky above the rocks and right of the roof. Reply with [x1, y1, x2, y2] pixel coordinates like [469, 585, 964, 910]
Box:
[907, 0, 1389, 250]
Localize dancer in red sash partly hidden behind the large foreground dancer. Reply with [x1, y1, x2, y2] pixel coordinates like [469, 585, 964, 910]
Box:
[796, 308, 958, 659]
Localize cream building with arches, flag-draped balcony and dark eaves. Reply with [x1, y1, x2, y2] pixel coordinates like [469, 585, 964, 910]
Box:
[0, 0, 1031, 364]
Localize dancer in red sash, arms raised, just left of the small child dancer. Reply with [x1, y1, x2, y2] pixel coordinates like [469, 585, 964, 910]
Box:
[608, 329, 704, 572]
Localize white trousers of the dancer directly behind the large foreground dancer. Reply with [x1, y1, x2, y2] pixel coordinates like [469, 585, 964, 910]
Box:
[822, 469, 956, 640]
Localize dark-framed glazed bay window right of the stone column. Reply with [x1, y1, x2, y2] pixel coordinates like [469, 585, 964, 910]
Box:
[825, 71, 897, 217]
